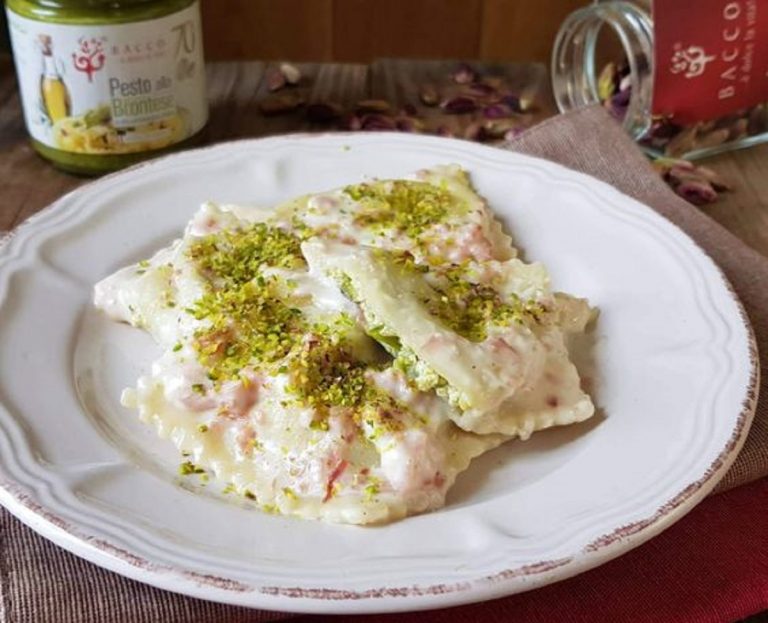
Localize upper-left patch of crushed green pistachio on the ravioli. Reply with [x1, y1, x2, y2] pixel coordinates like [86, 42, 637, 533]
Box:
[187, 223, 304, 286]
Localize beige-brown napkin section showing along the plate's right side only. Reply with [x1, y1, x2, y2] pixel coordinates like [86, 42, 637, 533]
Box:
[507, 106, 768, 491]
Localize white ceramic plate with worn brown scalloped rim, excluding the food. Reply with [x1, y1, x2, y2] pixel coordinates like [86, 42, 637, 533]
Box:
[0, 134, 758, 612]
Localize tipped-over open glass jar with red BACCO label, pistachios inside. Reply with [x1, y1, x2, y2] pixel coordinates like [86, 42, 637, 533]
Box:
[551, 0, 768, 158]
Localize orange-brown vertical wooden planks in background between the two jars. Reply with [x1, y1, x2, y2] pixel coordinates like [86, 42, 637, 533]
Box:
[201, 0, 589, 63]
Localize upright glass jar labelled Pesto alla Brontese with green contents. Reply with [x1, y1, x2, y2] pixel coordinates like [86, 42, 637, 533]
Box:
[6, 0, 208, 175]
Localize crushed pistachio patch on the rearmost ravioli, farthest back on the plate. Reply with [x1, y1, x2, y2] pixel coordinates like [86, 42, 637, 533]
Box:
[344, 180, 455, 238]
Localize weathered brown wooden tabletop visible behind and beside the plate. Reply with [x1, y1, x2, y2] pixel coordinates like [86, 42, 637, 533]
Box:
[0, 57, 768, 255]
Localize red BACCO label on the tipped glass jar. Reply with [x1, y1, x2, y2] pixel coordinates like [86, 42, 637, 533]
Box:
[652, 0, 768, 124]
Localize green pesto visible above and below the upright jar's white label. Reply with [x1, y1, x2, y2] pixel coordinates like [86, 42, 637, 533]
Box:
[6, 0, 207, 175]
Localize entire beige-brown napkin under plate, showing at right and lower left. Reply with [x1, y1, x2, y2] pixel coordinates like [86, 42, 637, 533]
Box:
[0, 107, 768, 623]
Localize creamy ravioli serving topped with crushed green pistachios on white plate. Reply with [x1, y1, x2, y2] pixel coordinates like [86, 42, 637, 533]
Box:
[94, 166, 594, 524]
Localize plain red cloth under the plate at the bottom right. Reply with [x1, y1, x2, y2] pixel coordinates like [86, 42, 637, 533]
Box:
[302, 478, 768, 623]
